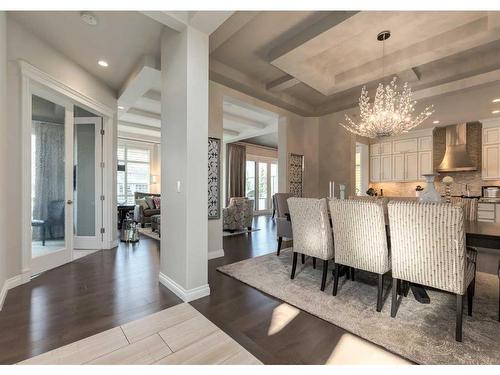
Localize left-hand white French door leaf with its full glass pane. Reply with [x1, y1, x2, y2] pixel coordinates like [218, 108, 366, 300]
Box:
[31, 88, 73, 275]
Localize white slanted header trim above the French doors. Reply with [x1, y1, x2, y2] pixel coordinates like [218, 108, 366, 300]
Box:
[18, 60, 116, 118]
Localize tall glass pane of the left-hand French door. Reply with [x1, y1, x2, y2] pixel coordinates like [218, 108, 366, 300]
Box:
[31, 95, 65, 257]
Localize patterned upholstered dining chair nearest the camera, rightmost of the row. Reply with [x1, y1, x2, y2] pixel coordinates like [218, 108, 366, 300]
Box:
[388, 202, 477, 341]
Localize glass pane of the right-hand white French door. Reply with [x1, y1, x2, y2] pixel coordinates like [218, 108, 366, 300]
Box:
[73, 123, 96, 237]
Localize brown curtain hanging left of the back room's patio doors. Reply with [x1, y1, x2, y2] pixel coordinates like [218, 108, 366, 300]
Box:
[226, 143, 247, 204]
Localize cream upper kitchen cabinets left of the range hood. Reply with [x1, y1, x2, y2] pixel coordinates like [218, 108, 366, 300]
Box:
[370, 129, 433, 182]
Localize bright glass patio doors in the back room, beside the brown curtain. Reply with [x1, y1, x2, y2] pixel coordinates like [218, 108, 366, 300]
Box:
[246, 157, 278, 213]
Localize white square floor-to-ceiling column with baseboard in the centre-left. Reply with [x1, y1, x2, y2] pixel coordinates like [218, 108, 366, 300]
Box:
[160, 26, 210, 301]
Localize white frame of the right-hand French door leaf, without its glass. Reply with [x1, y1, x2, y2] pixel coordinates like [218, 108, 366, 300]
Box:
[73, 117, 104, 253]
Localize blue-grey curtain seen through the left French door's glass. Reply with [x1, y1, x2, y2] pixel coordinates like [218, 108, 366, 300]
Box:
[31, 121, 65, 240]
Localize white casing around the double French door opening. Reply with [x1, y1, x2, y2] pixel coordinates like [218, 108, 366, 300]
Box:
[18, 60, 118, 282]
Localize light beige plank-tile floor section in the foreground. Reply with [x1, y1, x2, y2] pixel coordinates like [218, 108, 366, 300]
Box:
[19, 303, 261, 365]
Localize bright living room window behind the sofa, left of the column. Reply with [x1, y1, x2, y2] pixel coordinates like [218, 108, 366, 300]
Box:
[116, 140, 153, 205]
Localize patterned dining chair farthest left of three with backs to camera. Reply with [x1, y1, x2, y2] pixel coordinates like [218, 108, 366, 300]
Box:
[288, 198, 334, 291]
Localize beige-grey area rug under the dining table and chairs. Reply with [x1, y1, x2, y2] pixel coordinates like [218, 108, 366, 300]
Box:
[218, 248, 500, 365]
